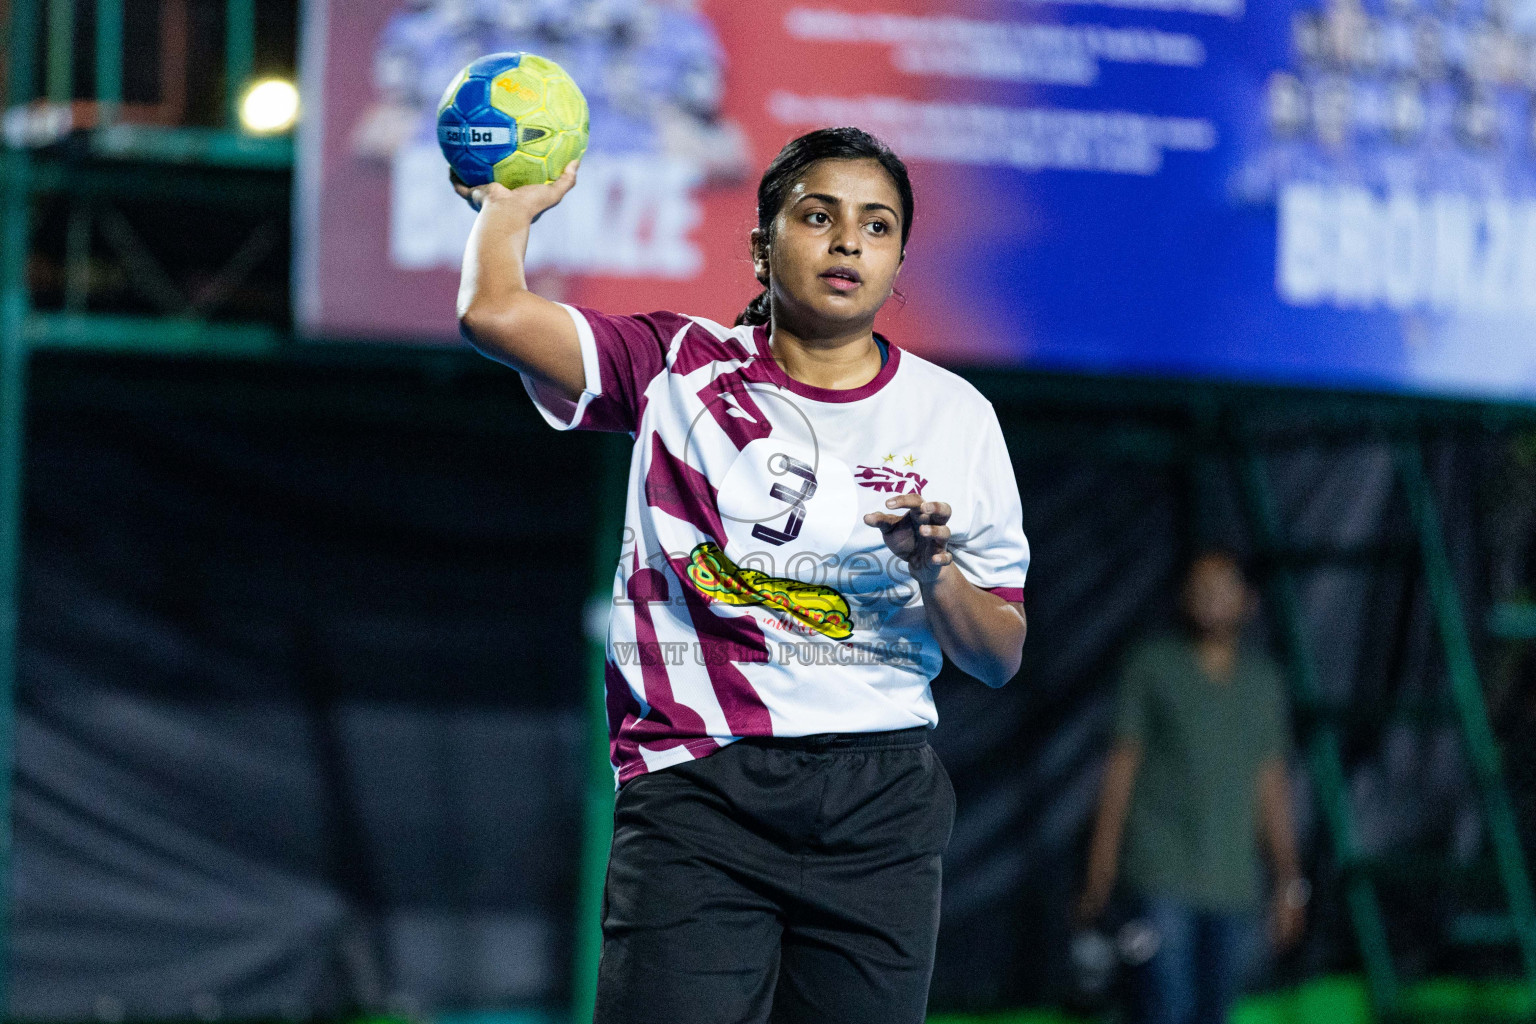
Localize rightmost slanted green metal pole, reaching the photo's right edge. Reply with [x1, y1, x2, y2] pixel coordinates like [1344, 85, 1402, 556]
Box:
[1396, 444, 1536, 998]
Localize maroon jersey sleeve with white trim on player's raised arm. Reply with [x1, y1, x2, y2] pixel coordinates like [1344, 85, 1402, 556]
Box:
[521, 302, 690, 434]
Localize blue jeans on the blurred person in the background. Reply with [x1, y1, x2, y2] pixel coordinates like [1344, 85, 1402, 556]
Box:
[1130, 898, 1255, 1024]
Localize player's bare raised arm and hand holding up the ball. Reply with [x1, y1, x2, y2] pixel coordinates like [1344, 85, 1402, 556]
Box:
[453, 160, 585, 401]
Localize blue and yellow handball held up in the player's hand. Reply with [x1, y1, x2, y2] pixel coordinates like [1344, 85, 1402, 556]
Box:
[438, 54, 591, 189]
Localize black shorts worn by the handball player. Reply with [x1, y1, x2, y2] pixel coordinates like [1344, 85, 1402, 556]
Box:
[594, 728, 955, 1024]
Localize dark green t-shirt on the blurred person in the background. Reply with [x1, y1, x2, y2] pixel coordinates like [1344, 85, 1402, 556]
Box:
[1115, 636, 1290, 912]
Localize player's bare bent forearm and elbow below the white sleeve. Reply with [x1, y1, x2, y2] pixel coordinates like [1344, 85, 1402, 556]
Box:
[919, 562, 1026, 686]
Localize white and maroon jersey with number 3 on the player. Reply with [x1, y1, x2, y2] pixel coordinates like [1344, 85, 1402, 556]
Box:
[522, 306, 1029, 785]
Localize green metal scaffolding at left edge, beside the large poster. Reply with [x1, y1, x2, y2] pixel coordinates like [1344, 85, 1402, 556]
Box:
[0, 0, 293, 1012]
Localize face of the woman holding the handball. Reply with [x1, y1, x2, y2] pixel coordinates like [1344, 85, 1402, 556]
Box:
[753, 160, 902, 333]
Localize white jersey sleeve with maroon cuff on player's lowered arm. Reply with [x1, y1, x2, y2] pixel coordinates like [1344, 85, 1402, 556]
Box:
[949, 402, 1029, 602]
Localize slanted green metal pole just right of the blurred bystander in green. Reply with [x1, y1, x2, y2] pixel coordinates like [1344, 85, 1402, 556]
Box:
[1238, 451, 1398, 1019]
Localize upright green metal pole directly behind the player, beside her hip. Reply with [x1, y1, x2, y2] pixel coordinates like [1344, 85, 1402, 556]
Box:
[571, 434, 631, 1024]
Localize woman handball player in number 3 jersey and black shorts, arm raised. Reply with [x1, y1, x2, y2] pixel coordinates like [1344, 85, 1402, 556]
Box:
[455, 127, 1029, 1024]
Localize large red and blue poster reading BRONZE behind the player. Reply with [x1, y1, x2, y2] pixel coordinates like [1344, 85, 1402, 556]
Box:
[298, 0, 1536, 399]
